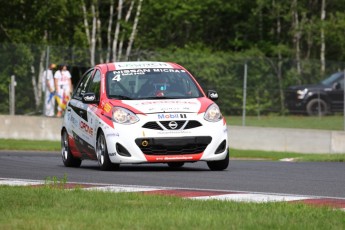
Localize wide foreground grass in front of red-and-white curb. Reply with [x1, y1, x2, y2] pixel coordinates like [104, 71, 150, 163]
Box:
[0, 186, 345, 230]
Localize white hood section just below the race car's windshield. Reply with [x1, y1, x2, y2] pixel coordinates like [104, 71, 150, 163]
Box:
[122, 99, 202, 114]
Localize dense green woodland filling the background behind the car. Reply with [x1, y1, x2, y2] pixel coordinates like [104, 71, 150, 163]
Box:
[0, 0, 345, 114]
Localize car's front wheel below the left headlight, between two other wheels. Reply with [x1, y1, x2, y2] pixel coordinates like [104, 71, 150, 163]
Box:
[96, 132, 120, 171]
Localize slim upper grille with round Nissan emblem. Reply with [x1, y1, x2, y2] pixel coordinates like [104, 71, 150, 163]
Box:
[142, 120, 202, 130]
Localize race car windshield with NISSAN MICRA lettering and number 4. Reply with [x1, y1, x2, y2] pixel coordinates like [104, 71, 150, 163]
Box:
[106, 68, 202, 100]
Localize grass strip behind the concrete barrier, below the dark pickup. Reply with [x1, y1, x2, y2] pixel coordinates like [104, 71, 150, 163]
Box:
[226, 116, 344, 131]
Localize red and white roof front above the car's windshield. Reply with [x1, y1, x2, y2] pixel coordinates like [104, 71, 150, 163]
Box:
[97, 61, 185, 71]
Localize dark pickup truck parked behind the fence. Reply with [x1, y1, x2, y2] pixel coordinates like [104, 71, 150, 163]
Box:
[285, 72, 344, 116]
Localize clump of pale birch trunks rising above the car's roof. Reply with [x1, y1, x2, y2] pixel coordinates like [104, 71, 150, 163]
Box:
[82, 0, 143, 66]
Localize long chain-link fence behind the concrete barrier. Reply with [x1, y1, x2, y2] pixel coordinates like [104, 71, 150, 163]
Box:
[0, 44, 345, 129]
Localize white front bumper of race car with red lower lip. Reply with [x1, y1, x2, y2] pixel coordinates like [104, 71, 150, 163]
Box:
[104, 114, 228, 164]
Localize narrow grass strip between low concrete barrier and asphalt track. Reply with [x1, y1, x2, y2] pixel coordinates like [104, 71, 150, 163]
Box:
[0, 139, 345, 162]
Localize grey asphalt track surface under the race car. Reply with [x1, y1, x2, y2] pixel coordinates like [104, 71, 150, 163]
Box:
[0, 151, 345, 199]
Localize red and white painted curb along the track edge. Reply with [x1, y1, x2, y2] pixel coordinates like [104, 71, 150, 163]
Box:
[0, 178, 345, 211]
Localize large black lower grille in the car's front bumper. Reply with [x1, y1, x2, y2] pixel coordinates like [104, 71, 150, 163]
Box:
[135, 136, 212, 155]
